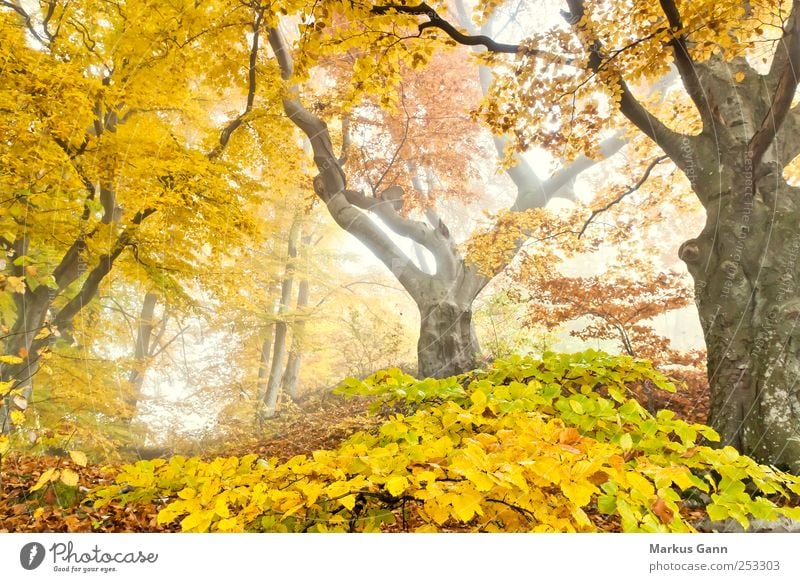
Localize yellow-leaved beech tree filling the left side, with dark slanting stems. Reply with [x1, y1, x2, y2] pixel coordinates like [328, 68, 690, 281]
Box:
[0, 1, 294, 432]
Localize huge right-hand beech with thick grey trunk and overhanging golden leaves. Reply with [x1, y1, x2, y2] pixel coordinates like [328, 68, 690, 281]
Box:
[360, 0, 800, 471]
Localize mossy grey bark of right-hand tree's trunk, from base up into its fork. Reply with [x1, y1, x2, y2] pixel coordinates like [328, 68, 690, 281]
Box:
[673, 60, 800, 472]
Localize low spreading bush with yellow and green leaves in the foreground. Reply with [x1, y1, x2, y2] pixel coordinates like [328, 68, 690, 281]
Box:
[92, 351, 800, 532]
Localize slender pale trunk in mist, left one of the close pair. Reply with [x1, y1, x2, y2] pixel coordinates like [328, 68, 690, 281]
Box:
[259, 220, 300, 419]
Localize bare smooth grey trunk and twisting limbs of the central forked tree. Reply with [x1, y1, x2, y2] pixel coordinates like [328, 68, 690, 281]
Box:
[269, 28, 608, 388]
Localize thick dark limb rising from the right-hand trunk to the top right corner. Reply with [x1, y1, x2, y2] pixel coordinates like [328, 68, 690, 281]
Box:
[747, 0, 800, 166]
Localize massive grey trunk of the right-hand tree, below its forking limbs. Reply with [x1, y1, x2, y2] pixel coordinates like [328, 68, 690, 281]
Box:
[680, 162, 800, 472]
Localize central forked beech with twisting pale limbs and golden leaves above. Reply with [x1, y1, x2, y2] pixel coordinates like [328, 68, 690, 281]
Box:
[262, 2, 636, 377]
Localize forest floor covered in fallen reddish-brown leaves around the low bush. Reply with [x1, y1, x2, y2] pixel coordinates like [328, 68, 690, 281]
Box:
[0, 376, 708, 533]
